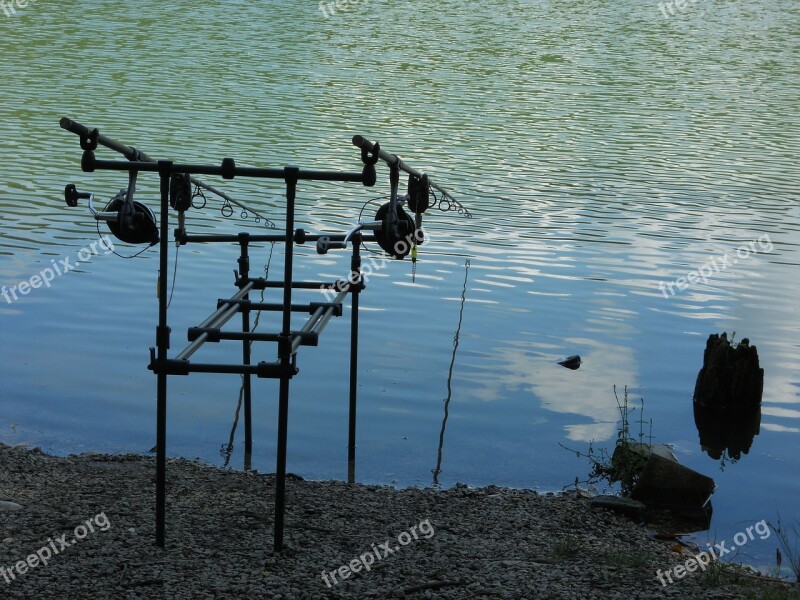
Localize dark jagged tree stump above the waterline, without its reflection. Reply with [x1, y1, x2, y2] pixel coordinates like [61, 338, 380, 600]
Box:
[694, 333, 764, 409]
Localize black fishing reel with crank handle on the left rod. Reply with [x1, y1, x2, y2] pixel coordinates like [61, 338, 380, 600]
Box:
[64, 171, 159, 246]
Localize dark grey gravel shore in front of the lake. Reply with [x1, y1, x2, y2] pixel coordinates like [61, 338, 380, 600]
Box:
[0, 445, 798, 600]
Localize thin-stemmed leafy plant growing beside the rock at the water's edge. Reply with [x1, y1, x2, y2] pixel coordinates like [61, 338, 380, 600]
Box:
[559, 386, 653, 496]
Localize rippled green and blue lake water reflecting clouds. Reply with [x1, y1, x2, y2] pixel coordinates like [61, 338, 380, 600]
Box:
[0, 0, 800, 568]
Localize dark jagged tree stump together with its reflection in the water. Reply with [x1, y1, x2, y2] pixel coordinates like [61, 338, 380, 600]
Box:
[694, 333, 764, 465]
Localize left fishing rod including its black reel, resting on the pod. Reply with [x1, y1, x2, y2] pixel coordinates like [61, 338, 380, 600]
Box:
[59, 117, 275, 234]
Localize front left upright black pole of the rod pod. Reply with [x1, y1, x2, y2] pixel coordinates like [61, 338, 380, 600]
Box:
[156, 160, 172, 548]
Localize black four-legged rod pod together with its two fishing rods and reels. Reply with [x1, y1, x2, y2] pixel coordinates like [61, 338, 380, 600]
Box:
[60, 117, 466, 554]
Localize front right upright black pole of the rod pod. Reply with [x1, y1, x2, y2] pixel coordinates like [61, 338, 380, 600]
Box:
[273, 167, 299, 553]
